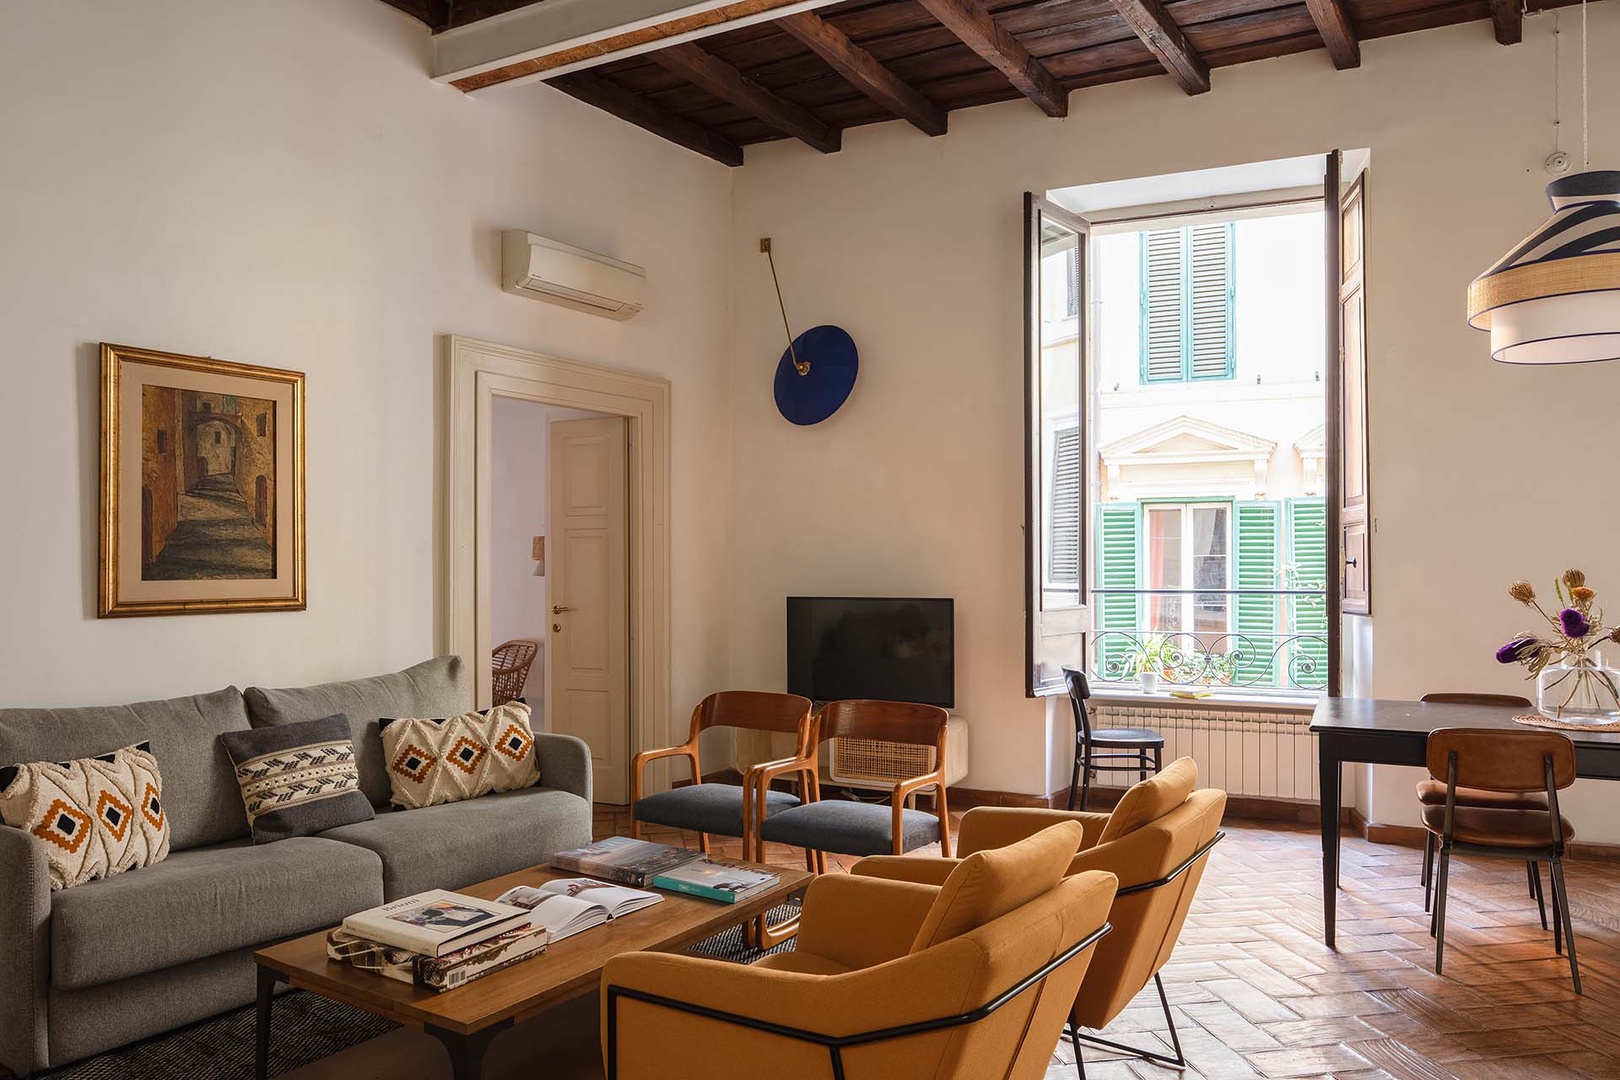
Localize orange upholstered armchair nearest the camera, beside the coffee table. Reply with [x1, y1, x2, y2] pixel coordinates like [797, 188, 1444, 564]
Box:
[601, 823, 1116, 1080]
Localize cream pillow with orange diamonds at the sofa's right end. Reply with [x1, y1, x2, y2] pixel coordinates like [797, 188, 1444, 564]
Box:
[382, 701, 539, 810]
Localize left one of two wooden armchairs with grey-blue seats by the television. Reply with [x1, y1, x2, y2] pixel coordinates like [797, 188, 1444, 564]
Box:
[630, 690, 815, 855]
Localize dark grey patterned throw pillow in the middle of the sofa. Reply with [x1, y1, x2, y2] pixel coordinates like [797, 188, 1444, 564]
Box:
[219, 712, 376, 844]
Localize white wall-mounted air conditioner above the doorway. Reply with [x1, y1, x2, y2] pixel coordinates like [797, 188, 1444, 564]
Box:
[501, 228, 646, 319]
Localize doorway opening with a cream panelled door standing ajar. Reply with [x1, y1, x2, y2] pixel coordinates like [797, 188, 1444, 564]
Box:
[489, 393, 630, 803]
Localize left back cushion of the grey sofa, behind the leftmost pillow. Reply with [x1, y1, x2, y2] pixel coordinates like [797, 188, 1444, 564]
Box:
[0, 687, 248, 852]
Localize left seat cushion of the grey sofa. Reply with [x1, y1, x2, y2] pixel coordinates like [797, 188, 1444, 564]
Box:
[50, 837, 382, 989]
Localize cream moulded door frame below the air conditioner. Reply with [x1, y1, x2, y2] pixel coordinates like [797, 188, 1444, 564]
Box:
[442, 335, 672, 799]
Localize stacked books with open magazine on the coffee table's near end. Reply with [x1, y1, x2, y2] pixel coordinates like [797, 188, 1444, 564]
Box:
[326, 878, 664, 991]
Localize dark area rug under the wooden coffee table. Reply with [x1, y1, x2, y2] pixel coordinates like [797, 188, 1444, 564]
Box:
[33, 900, 799, 1080]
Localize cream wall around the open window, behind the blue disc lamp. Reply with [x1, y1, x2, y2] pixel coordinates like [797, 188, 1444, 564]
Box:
[731, 3, 1620, 839]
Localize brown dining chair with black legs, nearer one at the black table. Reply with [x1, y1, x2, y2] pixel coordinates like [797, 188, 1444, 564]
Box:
[1422, 727, 1581, 994]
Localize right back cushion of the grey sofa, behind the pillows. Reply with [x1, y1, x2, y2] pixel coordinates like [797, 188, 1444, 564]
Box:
[244, 656, 473, 806]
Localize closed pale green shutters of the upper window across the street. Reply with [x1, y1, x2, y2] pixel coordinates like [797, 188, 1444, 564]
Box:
[1139, 222, 1236, 382]
